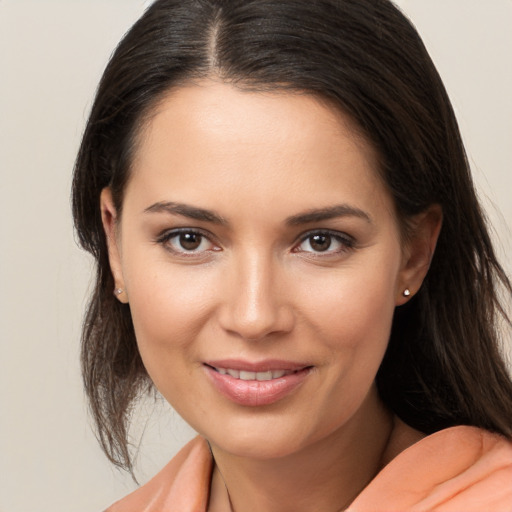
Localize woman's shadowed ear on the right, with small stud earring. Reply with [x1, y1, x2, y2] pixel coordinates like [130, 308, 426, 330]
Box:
[396, 204, 443, 306]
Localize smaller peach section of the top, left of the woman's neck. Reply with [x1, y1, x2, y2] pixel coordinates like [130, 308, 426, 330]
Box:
[105, 436, 212, 512]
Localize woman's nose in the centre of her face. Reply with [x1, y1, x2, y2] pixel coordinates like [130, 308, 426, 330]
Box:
[219, 252, 295, 341]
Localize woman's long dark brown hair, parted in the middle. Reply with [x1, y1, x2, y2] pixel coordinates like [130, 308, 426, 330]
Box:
[73, 0, 512, 470]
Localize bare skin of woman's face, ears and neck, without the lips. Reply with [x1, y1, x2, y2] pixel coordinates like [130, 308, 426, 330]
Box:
[101, 80, 441, 512]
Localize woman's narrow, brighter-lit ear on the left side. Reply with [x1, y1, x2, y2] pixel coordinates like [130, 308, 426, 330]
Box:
[100, 187, 128, 304]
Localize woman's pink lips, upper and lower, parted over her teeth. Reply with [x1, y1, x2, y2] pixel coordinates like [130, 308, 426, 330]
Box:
[203, 359, 312, 407]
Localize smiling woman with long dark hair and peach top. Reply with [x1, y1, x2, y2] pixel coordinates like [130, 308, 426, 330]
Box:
[73, 0, 512, 512]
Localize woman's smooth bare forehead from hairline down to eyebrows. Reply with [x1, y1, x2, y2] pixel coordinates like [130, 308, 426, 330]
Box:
[128, 82, 390, 221]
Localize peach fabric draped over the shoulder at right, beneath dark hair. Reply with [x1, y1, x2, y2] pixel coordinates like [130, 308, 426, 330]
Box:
[349, 426, 512, 512]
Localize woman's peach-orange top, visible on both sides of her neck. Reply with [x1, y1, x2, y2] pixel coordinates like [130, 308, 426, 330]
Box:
[106, 423, 512, 512]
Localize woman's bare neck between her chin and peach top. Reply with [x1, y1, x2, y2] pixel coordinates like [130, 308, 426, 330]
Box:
[209, 390, 393, 512]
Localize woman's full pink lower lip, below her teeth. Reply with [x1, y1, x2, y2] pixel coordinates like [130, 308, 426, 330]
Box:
[205, 366, 311, 407]
